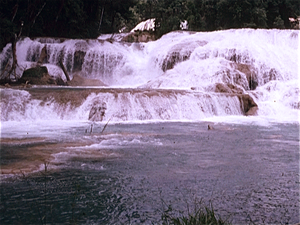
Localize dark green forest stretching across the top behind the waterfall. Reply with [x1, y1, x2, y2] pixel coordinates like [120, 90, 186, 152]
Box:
[0, 0, 300, 49]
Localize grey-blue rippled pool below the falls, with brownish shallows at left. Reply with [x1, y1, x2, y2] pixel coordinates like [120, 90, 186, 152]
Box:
[0, 122, 299, 224]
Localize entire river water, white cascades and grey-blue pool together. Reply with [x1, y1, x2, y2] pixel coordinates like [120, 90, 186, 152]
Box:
[0, 29, 300, 224]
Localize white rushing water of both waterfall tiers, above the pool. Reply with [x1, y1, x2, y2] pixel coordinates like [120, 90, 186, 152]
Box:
[0, 29, 300, 122]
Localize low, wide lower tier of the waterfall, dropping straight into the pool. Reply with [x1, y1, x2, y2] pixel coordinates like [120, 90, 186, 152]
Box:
[1, 89, 242, 121]
